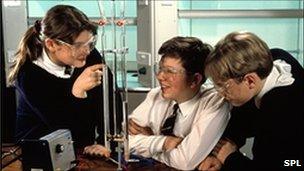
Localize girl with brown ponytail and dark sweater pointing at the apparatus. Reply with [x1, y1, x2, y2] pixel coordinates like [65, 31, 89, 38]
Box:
[9, 5, 110, 157]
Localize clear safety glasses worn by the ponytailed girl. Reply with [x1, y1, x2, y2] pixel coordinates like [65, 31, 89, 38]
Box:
[56, 36, 97, 51]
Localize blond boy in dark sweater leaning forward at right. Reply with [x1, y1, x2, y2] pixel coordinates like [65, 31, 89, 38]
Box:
[200, 32, 304, 171]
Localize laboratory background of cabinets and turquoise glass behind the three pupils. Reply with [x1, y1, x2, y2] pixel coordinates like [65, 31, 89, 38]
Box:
[0, 0, 304, 170]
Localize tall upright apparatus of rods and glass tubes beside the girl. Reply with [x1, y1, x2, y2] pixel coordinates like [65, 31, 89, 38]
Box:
[98, 0, 129, 170]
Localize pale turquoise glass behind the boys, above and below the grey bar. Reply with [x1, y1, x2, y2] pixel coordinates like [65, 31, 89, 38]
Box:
[178, 0, 304, 66]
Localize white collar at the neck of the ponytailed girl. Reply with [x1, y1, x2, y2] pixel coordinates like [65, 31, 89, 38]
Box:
[33, 49, 74, 78]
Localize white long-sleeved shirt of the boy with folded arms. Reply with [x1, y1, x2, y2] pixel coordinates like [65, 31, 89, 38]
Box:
[129, 86, 231, 170]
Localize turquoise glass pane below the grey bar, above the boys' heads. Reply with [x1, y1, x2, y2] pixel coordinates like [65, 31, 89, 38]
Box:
[179, 18, 303, 64]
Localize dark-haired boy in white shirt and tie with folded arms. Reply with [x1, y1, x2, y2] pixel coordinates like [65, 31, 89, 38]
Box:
[129, 37, 230, 170]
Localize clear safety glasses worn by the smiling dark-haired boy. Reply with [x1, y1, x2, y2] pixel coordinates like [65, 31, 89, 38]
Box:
[154, 63, 186, 78]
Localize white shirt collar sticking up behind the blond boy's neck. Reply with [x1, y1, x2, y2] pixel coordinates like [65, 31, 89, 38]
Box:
[255, 59, 295, 108]
